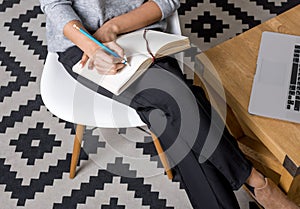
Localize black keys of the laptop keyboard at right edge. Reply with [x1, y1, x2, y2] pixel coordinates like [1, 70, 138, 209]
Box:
[286, 45, 300, 111]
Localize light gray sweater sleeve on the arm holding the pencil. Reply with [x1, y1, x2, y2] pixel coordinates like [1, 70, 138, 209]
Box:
[40, 0, 80, 33]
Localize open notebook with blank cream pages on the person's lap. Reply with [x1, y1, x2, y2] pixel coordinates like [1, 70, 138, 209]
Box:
[73, 30, 190, 95]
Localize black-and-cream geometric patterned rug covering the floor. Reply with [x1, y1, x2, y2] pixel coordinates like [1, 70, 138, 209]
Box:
[0, 0, 299, 209]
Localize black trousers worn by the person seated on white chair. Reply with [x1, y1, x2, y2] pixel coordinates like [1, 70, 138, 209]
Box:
[58, 47, 252, 209]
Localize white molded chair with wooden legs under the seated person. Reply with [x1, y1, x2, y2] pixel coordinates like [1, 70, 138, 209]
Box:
[40, 12, 181, 179]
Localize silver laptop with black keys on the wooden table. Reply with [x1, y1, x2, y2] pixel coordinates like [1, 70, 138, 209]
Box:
[248, 32, 300, 123]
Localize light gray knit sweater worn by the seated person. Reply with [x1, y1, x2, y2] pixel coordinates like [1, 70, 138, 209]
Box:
[40, 0, 180, 52]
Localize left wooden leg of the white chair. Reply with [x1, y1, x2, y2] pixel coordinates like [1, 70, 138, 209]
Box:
[70, 124, 85, 179]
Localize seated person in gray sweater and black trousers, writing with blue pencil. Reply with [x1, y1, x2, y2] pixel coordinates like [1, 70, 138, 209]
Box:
[40, 0, 298, 209]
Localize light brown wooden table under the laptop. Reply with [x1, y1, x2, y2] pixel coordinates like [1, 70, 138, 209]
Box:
[195, 5, 300, 204]
